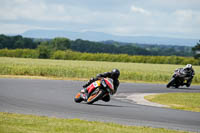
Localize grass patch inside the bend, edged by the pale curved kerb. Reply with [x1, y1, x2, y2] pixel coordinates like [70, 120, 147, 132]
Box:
[145, 93, 200, 112]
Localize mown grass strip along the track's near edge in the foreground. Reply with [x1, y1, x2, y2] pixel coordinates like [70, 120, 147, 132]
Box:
[0, 112, 191, 133]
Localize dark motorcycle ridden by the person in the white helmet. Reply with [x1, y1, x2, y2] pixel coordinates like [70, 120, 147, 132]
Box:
[166, 68, 189, 88]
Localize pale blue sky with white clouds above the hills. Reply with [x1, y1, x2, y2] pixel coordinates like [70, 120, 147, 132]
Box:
[0, 0, 200, 39]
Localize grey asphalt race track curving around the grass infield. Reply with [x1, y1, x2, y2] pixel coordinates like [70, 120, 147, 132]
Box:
[0, 78, 200, 132]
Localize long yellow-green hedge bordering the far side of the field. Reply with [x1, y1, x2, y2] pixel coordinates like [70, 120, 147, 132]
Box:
[0, 48, 200, 65]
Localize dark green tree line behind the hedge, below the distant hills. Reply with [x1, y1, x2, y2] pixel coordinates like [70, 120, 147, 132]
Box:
[0, 35, 198, 58]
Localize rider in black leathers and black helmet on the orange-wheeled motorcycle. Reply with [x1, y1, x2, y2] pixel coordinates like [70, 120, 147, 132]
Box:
[83, 69, 120, 102]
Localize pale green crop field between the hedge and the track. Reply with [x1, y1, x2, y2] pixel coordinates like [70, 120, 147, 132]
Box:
[0, 57, 200, 84]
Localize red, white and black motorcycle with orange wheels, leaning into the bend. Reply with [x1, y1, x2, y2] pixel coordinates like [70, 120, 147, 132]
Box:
[74, 78, 114, 104]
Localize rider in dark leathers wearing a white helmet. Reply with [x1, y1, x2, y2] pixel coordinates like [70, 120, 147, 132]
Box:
[176, 64, 195, 87]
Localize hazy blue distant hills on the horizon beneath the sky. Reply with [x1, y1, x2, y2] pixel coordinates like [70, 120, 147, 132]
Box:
[21, 30, 199, 46]
